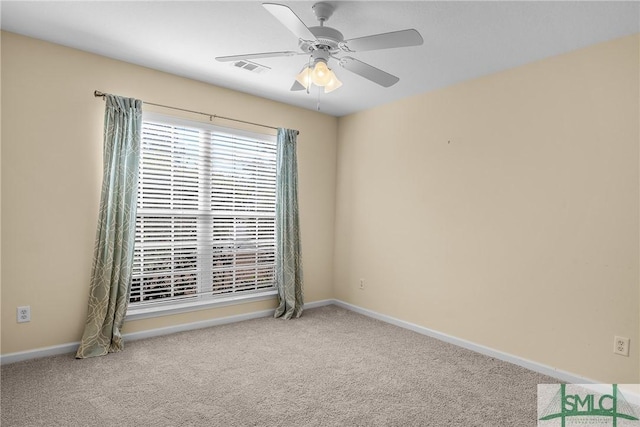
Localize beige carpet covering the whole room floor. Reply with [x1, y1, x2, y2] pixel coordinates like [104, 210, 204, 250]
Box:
[1, 306, 558, 427]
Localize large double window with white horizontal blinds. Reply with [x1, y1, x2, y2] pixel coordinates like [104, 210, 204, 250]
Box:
[129, 114, 276, 311]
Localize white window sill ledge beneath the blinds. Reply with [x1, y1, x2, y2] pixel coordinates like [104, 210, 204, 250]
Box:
[125, 289, 278, 321]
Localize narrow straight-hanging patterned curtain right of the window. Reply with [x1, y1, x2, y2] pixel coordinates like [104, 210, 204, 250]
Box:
[275, 128, 303, 319]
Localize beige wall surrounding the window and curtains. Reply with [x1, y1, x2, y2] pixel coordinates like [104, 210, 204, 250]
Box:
[1, 33, 337, 354]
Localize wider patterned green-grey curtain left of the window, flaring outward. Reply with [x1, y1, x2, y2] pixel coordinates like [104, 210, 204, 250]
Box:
[76, 95, 142, 358]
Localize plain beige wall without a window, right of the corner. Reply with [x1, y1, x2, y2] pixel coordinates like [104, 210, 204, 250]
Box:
[334, 35, 640, 383]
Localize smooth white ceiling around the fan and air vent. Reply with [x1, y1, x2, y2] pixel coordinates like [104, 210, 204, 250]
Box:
[0, 0, 640, 116]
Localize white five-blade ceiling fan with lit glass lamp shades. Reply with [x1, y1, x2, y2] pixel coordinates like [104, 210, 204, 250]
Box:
[216, 2, 423, 93]
